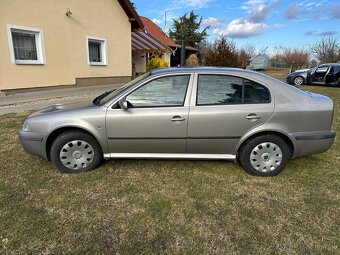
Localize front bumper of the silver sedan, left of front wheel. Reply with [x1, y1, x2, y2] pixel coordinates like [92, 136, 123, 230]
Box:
[19, 131, 48, 160]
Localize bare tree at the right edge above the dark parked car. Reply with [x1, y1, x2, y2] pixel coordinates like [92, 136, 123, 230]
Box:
[310, 36, 340, 63]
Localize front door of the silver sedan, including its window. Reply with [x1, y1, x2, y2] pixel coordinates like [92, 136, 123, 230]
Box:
[106, 74, 192, 153]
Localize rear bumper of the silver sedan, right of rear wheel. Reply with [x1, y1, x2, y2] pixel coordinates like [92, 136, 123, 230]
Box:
[291, 130, 336, 158]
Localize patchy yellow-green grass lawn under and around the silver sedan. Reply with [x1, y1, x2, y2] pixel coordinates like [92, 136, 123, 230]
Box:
[0, 70, 340, 254]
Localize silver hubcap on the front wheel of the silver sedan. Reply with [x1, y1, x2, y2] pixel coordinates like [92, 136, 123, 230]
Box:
[59, 140, 94, 170]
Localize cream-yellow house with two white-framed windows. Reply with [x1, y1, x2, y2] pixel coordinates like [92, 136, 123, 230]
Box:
[0, 0, 143, 91]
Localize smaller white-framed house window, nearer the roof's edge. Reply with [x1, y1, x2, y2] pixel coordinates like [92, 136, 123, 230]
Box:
[87, 37, 107, 65]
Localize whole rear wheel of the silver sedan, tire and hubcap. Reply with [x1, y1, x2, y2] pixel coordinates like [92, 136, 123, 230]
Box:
[239, 135, 291, 176]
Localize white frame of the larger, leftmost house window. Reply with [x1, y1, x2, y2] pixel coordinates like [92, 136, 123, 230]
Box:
[6, 24, 46, 65]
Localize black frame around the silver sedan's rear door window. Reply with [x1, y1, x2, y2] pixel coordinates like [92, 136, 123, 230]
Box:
[195, 73, 272, 107]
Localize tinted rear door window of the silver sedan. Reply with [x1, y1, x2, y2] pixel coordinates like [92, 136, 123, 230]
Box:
[196, 75, 270, 106]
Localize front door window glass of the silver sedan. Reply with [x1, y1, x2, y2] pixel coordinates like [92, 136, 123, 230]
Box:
[126, 75, 190, 108]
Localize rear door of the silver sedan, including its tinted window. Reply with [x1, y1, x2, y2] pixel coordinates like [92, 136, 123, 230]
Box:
[187, 73, 274, 154]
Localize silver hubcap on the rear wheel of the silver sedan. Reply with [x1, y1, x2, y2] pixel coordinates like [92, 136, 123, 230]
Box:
[250, 142, 282, 172]
